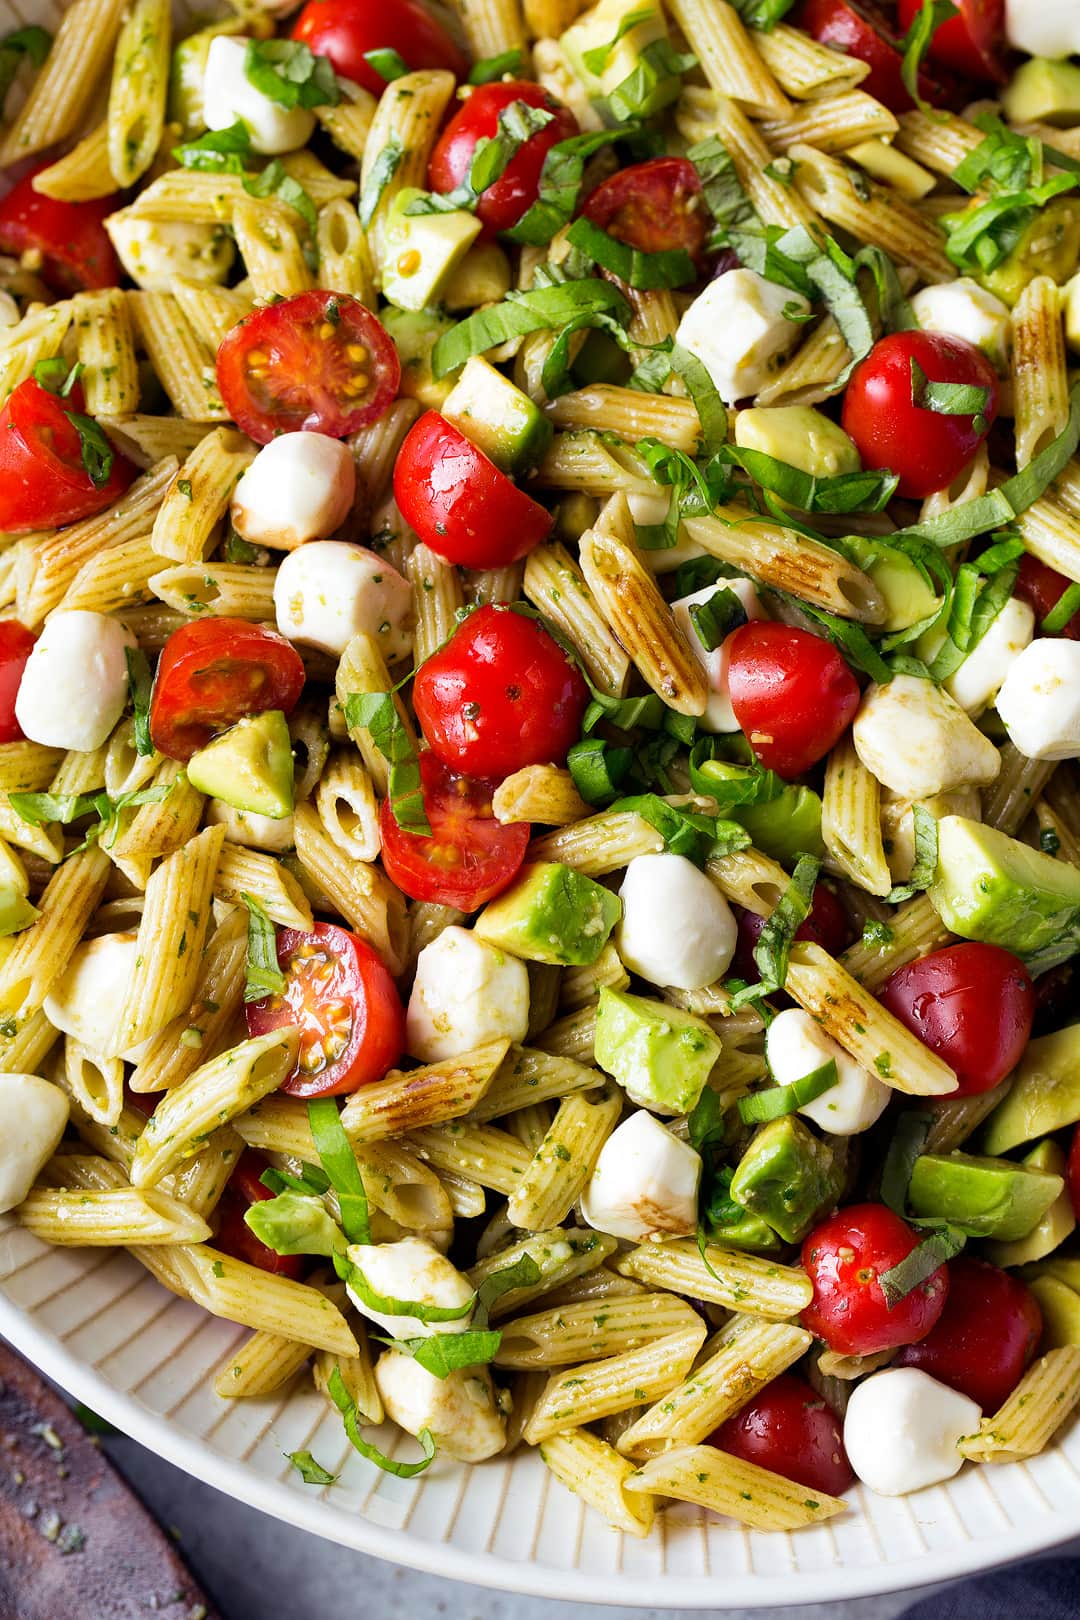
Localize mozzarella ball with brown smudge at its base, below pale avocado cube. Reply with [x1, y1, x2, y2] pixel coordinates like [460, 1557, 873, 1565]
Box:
[581, 1108, 701, 1243]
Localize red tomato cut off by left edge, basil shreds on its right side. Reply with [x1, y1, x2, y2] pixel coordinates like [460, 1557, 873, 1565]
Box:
[0, 377, 134, 535]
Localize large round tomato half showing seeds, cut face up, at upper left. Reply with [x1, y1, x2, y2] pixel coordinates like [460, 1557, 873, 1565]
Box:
[217, 290, 402, 444]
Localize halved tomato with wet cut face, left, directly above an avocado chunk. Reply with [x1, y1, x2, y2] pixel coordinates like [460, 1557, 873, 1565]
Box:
[151, 619, 304, 760]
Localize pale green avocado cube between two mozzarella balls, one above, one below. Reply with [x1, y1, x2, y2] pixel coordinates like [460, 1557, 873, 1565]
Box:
[593, 987, 721, 1115]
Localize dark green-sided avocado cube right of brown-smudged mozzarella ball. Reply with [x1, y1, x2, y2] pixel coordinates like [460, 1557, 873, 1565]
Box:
[730, 1115, 844, 1243]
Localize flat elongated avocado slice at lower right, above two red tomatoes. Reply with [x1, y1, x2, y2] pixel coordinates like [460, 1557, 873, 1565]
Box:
[907, 1153, 1065, 1243]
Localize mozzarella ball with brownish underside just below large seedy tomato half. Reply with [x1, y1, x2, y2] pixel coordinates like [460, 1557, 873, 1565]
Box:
[232, 433, 356, 551]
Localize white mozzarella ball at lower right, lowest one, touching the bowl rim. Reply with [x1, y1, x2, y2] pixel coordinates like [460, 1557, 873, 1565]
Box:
[844, 1367, 983, 1497]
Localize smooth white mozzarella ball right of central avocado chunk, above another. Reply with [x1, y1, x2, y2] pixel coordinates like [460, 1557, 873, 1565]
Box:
[615, 854, 738, 990]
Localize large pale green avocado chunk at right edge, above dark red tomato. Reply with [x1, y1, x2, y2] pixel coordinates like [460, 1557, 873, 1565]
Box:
[926, 815, 1080, 972]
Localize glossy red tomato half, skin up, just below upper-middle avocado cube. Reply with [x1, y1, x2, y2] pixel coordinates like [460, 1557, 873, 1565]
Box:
[393, 410, 552, 569]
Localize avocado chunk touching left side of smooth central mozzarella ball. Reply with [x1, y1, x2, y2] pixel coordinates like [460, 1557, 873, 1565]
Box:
[476, 860, 622, 967]
